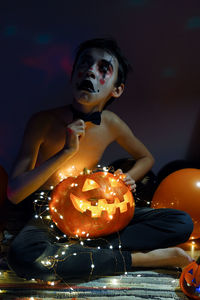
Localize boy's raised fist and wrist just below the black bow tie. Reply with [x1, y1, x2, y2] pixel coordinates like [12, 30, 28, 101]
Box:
[64, 119, 85, 152]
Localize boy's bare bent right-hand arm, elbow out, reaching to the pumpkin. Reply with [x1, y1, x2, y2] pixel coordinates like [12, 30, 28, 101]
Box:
[110, 113, 154, 181]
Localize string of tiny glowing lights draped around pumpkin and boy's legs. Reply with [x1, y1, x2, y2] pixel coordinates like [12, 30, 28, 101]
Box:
[34, 165, 131, 291]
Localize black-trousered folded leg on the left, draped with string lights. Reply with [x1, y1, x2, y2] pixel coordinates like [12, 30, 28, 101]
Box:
[8, 219, 132, 281]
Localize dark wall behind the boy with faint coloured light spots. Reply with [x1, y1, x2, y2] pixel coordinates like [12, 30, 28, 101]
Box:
[0, 0, 200, 172]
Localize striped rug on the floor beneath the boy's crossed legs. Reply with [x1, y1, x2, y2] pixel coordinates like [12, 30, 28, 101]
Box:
[0, 239, 200, 300]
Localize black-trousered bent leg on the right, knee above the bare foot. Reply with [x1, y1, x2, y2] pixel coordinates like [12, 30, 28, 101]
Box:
[87, 207, 193, 251]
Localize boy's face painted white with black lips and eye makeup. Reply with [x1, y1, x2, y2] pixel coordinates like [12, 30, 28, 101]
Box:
[72, 48, 122, 107]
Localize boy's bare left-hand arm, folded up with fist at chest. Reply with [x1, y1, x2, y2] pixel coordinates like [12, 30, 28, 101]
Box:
[7, 114, 84, 204]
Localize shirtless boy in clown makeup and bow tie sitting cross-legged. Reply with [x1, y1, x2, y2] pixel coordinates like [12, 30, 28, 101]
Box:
[8, 39, 193, 280]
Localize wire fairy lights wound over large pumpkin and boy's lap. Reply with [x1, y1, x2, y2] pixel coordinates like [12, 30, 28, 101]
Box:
[30, 165, 130, 288]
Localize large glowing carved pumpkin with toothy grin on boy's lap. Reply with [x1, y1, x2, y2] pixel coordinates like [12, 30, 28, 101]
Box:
[49, 172, 135, 238]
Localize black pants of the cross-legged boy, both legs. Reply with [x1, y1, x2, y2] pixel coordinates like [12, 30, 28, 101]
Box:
[8, 202, 193, 280]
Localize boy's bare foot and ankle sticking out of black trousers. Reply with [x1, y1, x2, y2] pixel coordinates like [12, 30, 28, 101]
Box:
[132, 247, 193, 268]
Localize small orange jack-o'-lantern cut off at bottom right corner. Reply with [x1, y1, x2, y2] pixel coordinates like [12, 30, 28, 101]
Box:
[180, 257, 200, 299]
